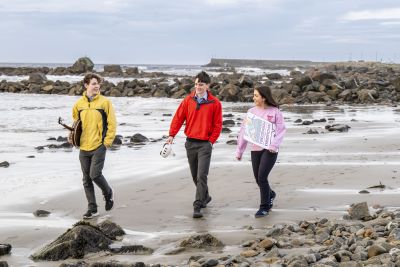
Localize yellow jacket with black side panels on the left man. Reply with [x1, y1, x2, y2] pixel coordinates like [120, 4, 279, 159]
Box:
[72, 92, 117, 151]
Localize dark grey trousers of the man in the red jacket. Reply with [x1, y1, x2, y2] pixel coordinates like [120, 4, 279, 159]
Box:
[185, 140, 212, 208]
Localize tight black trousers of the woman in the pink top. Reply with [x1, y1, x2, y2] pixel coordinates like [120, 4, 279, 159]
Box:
[251, 149, 278, 210]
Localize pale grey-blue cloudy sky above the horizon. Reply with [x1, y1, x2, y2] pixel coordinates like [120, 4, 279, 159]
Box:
[0, 0, 400, 64]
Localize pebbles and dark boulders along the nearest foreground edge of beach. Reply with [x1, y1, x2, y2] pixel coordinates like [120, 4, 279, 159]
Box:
[0, 202, 400, 267]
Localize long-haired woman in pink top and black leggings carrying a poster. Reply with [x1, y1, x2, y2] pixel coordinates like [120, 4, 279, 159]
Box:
[236, 85, 286, 218]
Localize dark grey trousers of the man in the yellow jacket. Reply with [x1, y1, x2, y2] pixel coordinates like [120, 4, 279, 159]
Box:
[79, 145, 111, 210]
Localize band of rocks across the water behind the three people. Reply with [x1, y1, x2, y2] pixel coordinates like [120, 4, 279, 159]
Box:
[0, 58, 400, 105]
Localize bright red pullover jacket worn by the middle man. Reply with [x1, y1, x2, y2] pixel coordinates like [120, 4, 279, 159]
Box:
[169, 91, 222, 144]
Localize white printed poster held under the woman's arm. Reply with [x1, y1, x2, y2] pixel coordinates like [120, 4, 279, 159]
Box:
[243, 112, 276, 149]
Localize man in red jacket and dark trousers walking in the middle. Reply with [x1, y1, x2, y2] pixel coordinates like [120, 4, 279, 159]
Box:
[167, 71, 222, 218]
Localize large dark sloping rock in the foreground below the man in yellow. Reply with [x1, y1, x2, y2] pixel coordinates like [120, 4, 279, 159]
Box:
[31, 221, 112, 261]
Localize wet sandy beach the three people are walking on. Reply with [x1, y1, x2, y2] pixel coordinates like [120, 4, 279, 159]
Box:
[0, 102, 400, 266]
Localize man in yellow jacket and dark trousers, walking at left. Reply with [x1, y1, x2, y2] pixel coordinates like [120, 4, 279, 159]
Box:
[72, 73, 117, 219]
